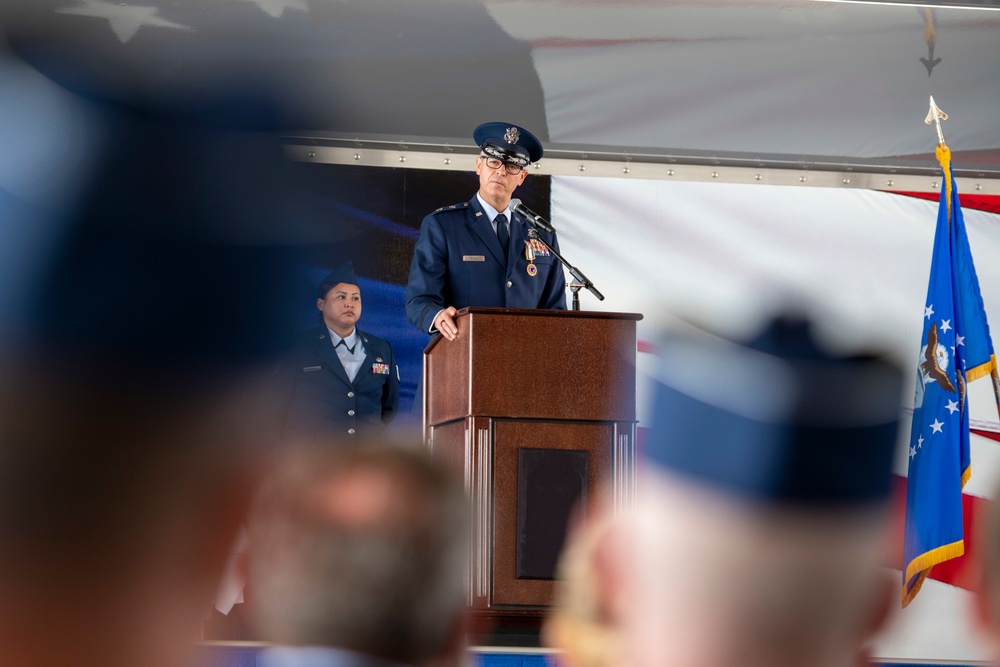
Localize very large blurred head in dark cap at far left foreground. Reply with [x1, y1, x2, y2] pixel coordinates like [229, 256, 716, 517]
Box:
[0, 53, 302, 667]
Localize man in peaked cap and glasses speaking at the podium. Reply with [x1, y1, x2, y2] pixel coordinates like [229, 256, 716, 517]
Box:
[406, 123, 566, 340]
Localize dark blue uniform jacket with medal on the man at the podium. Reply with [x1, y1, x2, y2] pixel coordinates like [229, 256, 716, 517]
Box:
[406, 197, 566, 332]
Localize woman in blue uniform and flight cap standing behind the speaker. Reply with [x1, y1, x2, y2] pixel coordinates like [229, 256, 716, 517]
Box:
[285, 262, 399, 443]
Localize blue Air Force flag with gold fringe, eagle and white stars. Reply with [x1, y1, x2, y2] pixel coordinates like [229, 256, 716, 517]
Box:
[903, 144, 997, 607]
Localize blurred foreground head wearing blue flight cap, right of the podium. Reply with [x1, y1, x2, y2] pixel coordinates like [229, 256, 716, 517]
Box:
[564, 320, 901, 667]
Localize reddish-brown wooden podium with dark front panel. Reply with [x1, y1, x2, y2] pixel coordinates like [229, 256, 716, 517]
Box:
[423, 308, 642, 625]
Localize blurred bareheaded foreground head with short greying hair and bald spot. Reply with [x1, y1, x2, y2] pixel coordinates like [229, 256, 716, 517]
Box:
[248, 445, 469, 665]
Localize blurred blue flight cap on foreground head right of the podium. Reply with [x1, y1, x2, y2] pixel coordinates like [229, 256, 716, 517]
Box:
[645, 318, 902, 509]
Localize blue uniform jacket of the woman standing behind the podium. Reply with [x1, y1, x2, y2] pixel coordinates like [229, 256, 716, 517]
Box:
[283, 327, 399, 444]
